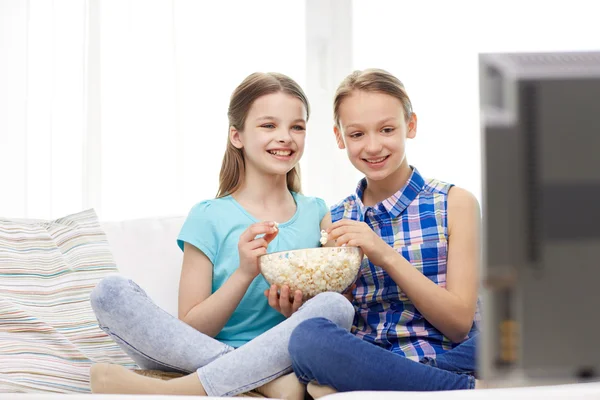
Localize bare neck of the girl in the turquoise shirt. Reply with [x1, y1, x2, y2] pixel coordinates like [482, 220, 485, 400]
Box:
[233, 169, 291, 208]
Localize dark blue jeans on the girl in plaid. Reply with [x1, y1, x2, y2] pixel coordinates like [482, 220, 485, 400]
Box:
[288, 318, 477, 392]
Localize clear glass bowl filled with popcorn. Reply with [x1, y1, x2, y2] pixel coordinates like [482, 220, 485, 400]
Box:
[259, 246, 362, 300]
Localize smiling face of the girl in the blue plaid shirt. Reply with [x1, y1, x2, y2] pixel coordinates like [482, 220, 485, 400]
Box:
[334, 90, 417, 181]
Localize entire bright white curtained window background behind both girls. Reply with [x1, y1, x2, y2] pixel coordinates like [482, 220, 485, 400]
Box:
[0, 0, 600, 220]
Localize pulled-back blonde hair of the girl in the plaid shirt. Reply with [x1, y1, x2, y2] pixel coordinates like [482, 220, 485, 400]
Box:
[333, 68, 413, 128]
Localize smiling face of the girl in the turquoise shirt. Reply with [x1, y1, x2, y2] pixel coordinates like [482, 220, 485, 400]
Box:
[230, 92, 307, 179]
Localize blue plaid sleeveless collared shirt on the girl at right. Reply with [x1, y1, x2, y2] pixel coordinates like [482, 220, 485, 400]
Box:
[331, 168, 480, 361]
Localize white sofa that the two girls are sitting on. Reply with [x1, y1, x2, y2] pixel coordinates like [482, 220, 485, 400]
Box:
[5, 217, 600, 400]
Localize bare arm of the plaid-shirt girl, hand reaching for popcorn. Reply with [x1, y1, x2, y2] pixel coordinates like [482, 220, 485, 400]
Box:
[334, 187, 480, 342]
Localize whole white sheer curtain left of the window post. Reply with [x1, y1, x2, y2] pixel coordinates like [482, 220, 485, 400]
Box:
[0, 0, 306, 220]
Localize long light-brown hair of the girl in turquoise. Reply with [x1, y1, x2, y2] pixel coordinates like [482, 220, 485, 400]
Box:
[217, 72, 310, 198]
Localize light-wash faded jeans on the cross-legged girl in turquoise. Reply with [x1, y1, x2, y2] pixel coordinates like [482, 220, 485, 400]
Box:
[90, 275, 354, 396]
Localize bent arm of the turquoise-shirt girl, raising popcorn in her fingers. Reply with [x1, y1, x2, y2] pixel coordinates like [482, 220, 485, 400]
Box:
[179, 222, 277, 337]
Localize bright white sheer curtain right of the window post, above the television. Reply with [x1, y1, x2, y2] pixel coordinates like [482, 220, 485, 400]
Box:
[353, 0, 600, 199]
